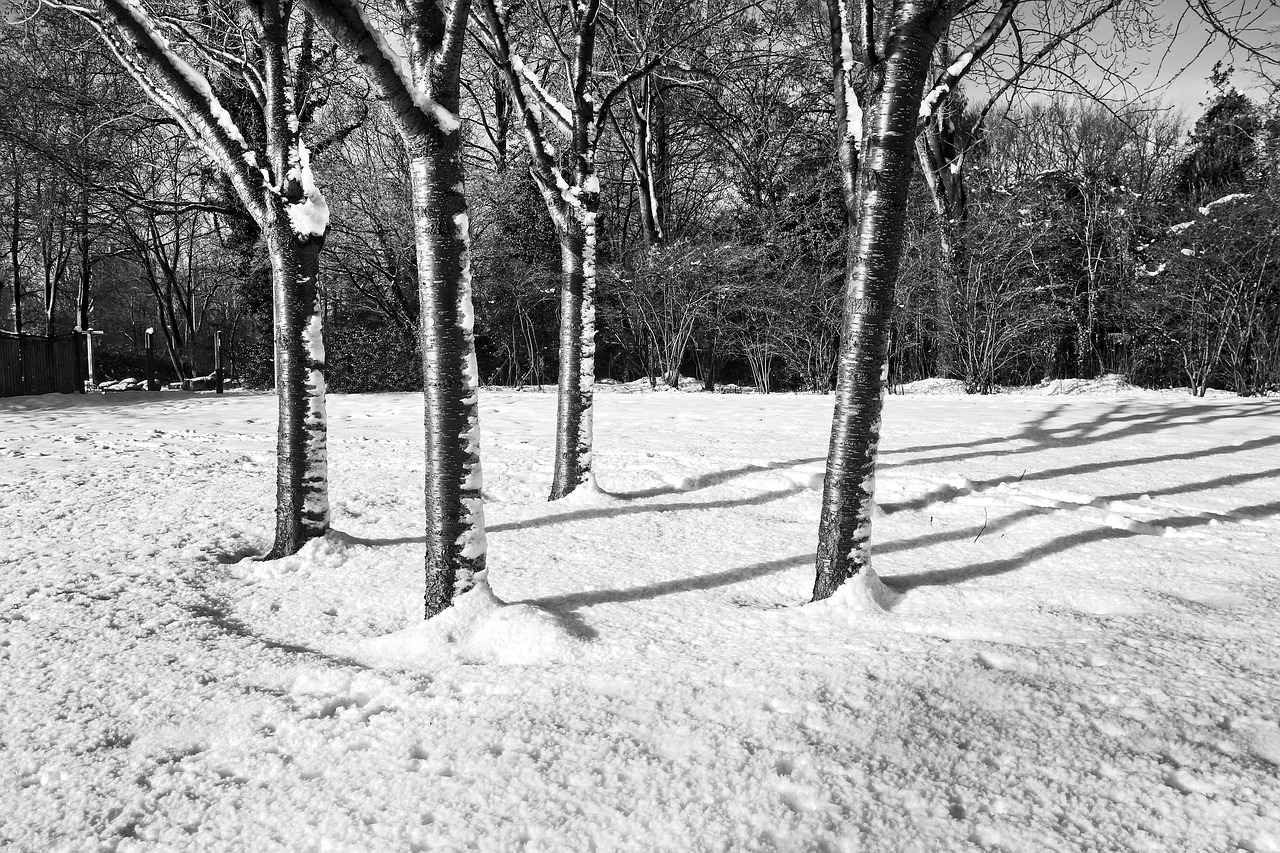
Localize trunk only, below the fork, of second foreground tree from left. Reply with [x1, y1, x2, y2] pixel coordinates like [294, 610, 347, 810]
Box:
[410, 144, 486, 619]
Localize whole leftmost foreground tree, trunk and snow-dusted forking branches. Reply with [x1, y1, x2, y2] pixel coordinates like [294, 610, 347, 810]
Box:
[45, 0, 329, 558]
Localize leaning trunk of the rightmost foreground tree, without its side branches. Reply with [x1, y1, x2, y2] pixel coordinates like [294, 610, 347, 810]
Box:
[813, 0, 946, 601]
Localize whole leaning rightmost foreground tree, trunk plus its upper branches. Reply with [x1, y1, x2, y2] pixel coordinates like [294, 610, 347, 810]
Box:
[813, 0, 1016, 601]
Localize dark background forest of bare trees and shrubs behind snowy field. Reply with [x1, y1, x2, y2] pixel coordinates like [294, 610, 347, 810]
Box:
[0, 3, 1280, 394]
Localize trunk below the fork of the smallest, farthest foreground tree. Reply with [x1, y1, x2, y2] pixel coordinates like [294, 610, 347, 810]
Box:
[548, 211, 595, 501]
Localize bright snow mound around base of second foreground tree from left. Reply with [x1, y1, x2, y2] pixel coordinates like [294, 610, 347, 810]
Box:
[353, 579, 581, 667]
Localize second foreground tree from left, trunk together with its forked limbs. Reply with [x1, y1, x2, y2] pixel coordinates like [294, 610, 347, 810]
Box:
[305, 0, 485, 619]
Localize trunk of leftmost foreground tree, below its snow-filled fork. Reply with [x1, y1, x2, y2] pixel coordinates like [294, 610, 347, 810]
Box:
[264, 220, 329, 560]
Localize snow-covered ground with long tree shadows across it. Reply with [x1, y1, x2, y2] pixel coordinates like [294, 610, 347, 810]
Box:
[0, 392, 1280, 853]
